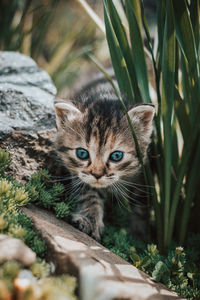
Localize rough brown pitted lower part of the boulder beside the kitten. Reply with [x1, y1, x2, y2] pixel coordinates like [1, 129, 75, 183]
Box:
[0, 129, 57, 181]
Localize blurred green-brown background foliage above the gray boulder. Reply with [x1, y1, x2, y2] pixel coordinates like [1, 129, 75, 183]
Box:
[0, 0, 109, 92]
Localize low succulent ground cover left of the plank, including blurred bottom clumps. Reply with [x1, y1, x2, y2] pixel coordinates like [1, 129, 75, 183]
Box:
[0, 148, 76, 300]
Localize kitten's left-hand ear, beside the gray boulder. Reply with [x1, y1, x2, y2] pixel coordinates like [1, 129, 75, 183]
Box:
[55, 102, 81, 129]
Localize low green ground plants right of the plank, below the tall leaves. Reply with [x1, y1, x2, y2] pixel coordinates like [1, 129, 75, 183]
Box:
[102, 225, 200, 300]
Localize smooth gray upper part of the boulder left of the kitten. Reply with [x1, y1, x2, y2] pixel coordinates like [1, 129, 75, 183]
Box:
[0, 52, 56, 136]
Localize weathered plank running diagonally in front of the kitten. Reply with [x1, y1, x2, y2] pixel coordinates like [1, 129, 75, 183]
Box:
[23, 206, 184, 300]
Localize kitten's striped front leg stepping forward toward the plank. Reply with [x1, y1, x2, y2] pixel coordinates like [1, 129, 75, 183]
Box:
[72, 190, 104, 241]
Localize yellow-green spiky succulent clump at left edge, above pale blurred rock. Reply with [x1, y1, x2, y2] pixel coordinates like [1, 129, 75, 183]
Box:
[0, 148, 46, 257]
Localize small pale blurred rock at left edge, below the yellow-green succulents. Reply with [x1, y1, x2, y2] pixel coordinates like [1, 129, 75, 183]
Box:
[0, 234, 36, 267]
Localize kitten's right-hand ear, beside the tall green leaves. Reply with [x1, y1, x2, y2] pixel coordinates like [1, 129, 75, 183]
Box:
[128, 104, 155, 134]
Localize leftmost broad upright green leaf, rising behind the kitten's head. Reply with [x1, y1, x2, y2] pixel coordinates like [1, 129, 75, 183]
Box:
[103, 0, 134, 103]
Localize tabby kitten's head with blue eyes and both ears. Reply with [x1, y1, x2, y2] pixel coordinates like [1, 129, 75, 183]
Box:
[55, 100, 155, 188]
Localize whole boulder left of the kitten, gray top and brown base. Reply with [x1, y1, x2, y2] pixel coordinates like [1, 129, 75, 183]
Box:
[0, 52, 56, 179]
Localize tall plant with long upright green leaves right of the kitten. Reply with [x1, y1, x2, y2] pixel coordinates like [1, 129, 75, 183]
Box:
[99, 0, 200, 251]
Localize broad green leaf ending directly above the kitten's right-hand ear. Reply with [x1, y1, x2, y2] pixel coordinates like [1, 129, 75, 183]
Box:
[125, 0, 151, 103]
